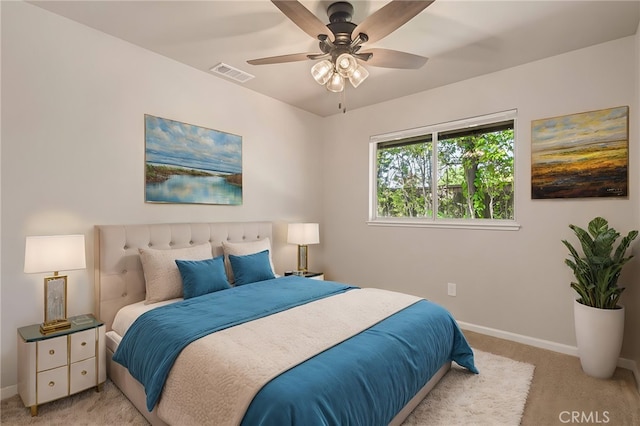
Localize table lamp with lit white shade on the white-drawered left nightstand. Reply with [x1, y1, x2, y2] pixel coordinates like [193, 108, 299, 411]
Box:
[24, 235, 86, 334]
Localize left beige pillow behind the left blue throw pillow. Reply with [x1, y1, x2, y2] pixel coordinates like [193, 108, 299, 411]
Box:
[139, 243, 211, 305]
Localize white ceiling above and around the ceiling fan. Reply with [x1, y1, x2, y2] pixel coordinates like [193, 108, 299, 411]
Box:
[30, 0, 640, 116]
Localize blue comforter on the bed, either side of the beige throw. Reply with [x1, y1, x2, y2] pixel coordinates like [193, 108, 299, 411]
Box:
[113, 277, 477, 426]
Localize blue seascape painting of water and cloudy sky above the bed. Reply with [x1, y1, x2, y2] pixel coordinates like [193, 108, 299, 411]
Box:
[144, 114, 242, 205]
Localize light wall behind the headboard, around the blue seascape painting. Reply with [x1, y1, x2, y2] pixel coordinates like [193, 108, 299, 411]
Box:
[1, 2, 322, 393]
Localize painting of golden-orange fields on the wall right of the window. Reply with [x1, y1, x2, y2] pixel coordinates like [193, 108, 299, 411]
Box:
[531, 106, 629, 199]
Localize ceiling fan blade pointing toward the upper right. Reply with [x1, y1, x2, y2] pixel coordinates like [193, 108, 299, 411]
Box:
[350, 0, 433, 43]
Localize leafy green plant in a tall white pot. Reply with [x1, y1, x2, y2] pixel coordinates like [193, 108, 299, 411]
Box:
[562, 217, 638, 379]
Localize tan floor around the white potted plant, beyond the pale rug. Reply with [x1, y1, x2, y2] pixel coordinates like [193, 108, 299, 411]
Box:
[464, 331, 640, 426]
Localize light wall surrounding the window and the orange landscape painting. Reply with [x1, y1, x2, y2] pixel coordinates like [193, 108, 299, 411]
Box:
[323, 37, 640, 357]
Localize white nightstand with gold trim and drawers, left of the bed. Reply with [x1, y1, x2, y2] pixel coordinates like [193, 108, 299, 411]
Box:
[18, 315, 107, 416]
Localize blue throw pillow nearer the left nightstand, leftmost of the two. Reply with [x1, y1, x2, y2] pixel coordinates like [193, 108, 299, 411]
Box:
[176, 256, 231, 299]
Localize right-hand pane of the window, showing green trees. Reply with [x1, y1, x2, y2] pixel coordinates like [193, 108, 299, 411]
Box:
[438, 121, 514, 219]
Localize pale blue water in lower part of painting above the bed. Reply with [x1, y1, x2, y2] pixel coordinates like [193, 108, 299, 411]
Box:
[145, 175, 242, 205]
